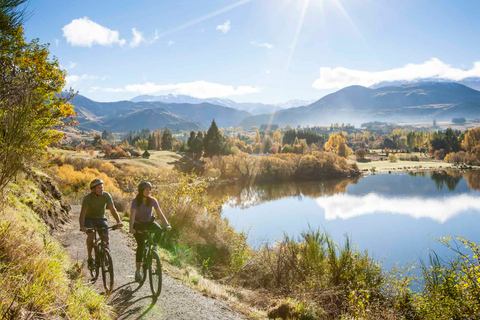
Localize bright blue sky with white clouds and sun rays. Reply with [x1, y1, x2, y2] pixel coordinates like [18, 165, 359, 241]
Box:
[25, 0, 480, 103]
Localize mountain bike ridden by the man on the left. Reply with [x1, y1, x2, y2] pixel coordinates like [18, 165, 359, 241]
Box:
[87, 226, 117, 295]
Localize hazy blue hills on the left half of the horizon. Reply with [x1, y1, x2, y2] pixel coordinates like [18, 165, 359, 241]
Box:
[71, 95, 251, 132]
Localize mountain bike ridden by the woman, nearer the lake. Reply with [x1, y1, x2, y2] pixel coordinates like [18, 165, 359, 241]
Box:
[136, 230, 165, 298]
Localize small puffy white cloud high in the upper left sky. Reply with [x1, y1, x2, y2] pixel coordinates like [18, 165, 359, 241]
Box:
[62, 17, 125, 47]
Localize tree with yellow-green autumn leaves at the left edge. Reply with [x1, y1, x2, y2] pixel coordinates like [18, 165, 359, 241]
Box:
[0, 24, 75, 192]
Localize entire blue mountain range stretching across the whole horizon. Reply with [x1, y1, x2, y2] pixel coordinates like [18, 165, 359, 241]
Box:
[72, 82, 480, 132]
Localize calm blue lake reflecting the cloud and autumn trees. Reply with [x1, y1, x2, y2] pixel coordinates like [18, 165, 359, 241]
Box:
[212, 171, 480, 268]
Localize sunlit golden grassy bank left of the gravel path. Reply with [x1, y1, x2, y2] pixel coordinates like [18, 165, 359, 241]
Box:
[0, 176, 113, 319]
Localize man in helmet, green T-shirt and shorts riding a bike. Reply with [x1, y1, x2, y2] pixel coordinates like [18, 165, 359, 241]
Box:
[79, 179, 123, 269]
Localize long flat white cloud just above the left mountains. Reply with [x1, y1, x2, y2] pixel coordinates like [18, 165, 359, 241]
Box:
[91, 81, 260, 99]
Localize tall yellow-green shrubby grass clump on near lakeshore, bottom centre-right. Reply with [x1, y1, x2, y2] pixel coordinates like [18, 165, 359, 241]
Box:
[231, 230, 384, 319]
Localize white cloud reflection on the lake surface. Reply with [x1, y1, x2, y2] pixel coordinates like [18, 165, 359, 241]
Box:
[317, 193, 480, 223]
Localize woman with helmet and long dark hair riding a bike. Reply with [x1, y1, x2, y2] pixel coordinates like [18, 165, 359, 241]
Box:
[130, 181, 171, 281]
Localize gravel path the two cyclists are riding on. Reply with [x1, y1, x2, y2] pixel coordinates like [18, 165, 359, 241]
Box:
[58, 206, 245, 320]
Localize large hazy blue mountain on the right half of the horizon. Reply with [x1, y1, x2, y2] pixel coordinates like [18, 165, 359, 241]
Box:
[241, 82, 480, 128]
